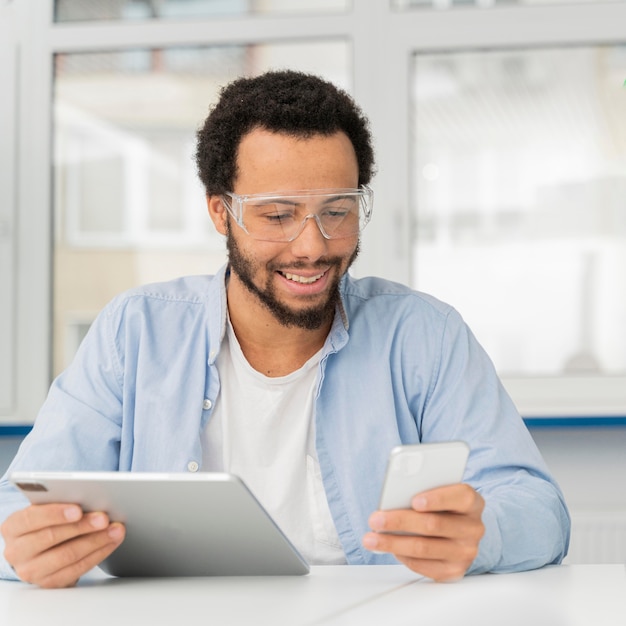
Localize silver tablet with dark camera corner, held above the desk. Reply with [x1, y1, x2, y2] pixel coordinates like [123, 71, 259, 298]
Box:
[11, 472, 309, 576]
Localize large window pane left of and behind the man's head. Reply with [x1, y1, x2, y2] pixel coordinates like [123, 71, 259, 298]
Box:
[53, 40, 352, 373]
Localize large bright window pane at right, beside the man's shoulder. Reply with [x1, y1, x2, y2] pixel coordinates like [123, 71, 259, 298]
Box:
[413, 46, 626, 376]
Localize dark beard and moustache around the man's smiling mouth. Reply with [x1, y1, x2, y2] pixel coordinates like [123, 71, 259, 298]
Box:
[226, 223, 359, 330]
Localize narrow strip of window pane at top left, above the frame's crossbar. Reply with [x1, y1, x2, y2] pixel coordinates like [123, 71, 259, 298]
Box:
[54, 0, 351, 22]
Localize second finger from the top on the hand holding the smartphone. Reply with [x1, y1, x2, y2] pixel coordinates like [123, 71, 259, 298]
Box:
[369, 509, 483, 539]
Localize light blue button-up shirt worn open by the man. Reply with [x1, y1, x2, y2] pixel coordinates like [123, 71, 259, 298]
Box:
[0, 260, 570, 578]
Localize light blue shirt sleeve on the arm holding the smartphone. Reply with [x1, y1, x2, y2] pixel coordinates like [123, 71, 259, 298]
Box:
[422, 310, 570, 573]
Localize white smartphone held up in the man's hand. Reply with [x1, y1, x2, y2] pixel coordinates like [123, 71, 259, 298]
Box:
[378, 441, 469, 510]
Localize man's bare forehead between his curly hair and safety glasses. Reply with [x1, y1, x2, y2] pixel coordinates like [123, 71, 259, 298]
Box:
[233, 128, 359, 194]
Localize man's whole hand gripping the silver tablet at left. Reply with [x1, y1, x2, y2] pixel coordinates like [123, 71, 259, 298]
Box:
[0, 504, 126, 588]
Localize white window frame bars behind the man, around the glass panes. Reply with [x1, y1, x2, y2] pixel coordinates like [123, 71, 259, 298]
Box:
[0, 0, 626, 425]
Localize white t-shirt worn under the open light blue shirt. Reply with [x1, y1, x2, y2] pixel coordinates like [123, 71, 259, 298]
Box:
[202, 322, 346, 565]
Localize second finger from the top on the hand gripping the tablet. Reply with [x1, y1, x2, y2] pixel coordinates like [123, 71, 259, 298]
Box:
[4, 513, 109, 568]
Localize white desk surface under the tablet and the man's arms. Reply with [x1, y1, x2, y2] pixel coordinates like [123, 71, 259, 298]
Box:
[0, 565, 626, 626]
